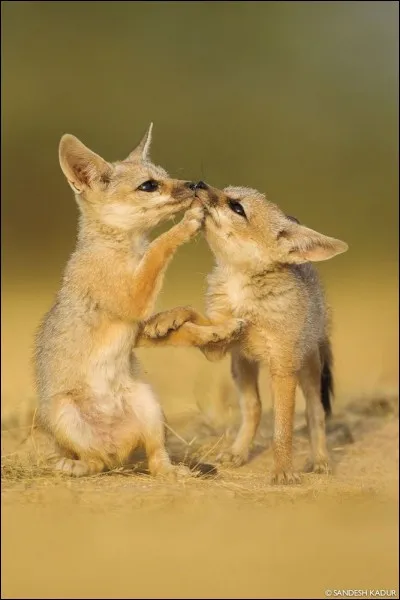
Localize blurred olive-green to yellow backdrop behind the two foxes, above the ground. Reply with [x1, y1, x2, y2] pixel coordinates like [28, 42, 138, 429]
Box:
[1, 2, 398, 412]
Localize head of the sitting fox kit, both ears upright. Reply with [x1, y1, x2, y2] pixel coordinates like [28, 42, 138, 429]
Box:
[59, 127, 194, 231]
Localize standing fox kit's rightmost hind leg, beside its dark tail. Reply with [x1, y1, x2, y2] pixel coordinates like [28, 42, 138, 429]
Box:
[299, 351, 331, 473]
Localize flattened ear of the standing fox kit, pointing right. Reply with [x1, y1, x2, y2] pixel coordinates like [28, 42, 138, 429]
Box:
[278, 223, 348, 263]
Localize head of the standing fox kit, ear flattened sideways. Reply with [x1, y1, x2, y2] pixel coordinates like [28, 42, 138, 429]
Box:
[196, 182, 347, 270]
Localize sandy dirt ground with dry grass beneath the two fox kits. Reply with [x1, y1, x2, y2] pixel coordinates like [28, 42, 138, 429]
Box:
[2, 397, 398, 598]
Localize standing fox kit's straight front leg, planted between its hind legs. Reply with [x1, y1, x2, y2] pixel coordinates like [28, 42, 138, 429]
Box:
[271, 371, 300, 484]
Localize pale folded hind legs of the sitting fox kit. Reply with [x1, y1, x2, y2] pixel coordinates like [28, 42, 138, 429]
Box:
[45, 382, 188, 477]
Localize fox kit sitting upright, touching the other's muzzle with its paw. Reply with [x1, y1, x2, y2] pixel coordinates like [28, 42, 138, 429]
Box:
[35, 126, 203, 476]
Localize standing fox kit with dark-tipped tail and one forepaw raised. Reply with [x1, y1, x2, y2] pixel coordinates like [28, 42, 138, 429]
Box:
[139, 182, 347, 483]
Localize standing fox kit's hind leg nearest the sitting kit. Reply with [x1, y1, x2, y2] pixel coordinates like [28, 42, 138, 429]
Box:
[218, 351, 261, 467]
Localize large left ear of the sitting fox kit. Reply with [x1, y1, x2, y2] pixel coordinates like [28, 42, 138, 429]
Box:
[58, 133, 112, 194]
